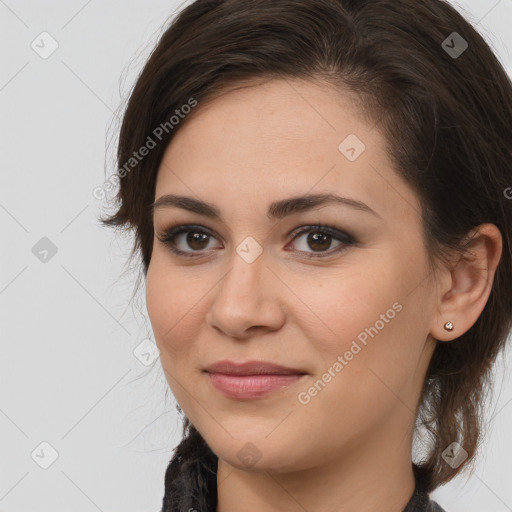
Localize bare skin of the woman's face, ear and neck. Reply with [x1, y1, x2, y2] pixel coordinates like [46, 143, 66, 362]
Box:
[146, 80, 501, 512]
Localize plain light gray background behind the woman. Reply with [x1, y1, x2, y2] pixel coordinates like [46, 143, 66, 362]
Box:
[0, 0, 512, 512]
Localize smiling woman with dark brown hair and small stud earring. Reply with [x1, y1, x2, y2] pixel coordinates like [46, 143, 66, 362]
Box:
[103, 0, 512, 512]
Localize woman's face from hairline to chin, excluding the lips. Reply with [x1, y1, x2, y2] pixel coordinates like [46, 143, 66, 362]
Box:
[146, 80, 437, 472]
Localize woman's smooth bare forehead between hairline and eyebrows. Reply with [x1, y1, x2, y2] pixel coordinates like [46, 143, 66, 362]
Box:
[155, 80, 419, 222]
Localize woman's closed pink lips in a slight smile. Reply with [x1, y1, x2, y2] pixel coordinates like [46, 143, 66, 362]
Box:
[204, 360, 306, 400]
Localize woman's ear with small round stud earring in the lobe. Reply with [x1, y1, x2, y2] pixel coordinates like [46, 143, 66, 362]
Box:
[430, 224, 502, 341]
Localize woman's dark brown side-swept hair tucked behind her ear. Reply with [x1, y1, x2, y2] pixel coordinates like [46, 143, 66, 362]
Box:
[102, 0, 512, 512]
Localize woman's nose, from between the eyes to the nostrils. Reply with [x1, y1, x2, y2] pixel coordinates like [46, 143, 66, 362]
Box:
[206, 245, 286, 339]
